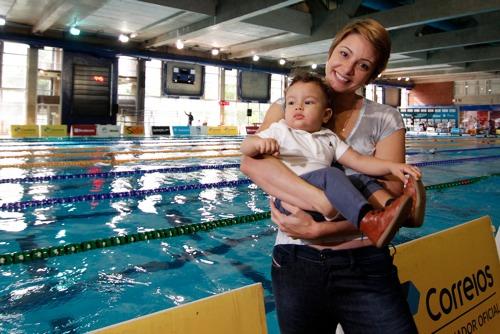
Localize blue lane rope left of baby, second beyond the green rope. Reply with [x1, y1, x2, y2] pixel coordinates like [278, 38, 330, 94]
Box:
[0, 163, 240, 183]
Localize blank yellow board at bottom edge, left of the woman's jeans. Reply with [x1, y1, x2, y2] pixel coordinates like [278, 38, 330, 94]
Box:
[94, 283, 267, 334]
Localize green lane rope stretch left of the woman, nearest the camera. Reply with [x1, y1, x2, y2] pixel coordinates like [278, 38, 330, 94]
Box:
[0, 211, 271, 266]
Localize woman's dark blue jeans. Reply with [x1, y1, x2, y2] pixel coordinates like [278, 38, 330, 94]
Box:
[272, 245, 417, 334]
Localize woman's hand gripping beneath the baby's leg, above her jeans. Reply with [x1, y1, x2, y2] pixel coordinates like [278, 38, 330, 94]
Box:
[269, 199, 319, 240]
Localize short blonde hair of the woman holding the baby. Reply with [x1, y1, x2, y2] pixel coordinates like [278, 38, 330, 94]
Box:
[328, 19, 391, 82]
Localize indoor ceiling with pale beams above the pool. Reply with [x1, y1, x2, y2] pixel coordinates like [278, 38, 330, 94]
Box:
[0, 0, 500, 82]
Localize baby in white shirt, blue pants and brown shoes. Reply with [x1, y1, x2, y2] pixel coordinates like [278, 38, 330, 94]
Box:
[240, 73, 420, 247]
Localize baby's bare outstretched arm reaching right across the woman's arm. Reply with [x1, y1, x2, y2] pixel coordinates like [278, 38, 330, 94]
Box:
[338, 148, 422, 182]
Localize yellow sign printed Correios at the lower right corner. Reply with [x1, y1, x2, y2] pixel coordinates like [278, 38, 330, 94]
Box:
[394, 217, 500, 334]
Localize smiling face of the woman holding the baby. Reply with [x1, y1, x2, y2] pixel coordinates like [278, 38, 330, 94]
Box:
[325, 34, 377, 93]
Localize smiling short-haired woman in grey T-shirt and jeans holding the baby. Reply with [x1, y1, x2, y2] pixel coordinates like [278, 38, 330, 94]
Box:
[241, 20, 420, 333]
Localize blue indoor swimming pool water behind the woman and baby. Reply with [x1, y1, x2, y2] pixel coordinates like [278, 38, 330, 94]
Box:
[0, 137, 500, 333]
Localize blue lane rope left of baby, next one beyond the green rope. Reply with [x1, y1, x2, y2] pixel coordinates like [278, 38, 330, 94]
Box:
[0, 179, 252, 211]
